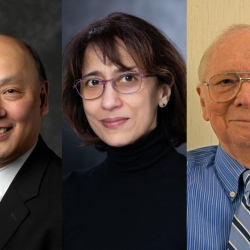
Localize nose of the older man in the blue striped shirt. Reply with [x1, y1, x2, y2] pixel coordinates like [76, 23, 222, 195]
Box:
[234, 78, 250, 108]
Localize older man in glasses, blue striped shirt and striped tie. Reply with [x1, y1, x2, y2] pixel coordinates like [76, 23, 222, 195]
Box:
[187, 24, 250, 250]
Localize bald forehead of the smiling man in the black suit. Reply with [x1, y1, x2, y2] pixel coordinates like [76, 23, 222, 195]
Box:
[0, 36, 37, 80]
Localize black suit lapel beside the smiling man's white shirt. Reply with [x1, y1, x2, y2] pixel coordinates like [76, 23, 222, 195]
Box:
[0, 136, 51, 249]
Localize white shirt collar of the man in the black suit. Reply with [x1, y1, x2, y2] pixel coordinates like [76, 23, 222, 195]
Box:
[0, 142, 37, 201]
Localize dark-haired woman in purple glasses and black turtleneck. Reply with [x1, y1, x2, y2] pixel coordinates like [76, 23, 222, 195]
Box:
[63, 13, 186, 250]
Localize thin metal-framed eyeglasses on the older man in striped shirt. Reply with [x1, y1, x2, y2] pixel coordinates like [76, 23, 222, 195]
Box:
[204, 72, 250, 102]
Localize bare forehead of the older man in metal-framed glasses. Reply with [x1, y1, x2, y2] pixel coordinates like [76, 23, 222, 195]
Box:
[206, 29, 250, 78]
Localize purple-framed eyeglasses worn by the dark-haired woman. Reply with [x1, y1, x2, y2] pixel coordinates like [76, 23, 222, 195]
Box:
[73, 72, 155, 100]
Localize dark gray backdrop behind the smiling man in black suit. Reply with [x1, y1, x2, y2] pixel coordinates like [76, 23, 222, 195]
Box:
[0, 0, 62, 156]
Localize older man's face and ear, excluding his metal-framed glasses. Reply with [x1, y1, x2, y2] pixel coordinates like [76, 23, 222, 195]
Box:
[197, 29, 250, 153]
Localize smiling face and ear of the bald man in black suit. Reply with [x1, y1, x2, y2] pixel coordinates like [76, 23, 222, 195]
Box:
[0, 36, 48, 168]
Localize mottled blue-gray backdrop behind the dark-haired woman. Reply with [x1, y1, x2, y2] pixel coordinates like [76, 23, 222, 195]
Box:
[62, 0, 186, 174]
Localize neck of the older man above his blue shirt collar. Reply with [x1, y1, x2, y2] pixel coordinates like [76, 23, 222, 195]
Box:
[221, 143, 250, 169]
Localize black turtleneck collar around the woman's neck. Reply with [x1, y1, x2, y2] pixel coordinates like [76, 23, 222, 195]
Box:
[103, 127, 175, 178]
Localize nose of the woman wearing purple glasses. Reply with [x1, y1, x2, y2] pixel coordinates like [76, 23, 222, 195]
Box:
[101, 81, 123, 110]
